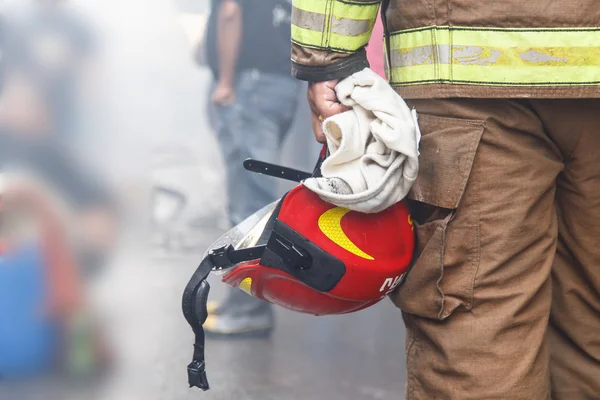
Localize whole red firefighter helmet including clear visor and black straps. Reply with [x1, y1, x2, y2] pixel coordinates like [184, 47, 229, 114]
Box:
[182, 154, 415, 390]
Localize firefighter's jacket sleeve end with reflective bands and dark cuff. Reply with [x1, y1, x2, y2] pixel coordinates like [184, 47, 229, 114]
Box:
[292, 0, 381, 82]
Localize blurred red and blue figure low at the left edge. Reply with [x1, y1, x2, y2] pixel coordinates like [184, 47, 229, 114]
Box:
[0, 173, 108, 382]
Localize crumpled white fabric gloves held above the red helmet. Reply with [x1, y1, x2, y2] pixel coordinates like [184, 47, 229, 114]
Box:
[304, 68, 421, 213]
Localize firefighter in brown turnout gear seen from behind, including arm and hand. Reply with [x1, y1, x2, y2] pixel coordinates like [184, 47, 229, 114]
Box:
[292, 0, 600, 400]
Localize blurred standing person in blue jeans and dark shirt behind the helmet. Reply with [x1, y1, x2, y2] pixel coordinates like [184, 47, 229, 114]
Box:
[204, 0, 300, 337]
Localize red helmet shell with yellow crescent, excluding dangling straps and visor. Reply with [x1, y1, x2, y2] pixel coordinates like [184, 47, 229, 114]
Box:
[222, 185, 415, 315]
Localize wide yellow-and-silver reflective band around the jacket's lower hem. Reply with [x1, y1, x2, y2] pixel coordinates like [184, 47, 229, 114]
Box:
[388, 27, 600, 86]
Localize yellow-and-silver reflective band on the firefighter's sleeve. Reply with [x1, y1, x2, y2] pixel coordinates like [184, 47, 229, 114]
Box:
[292, 0, 380, 52]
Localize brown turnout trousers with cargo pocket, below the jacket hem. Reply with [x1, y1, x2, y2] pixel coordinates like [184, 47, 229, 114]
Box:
[392, 99, 600, 400]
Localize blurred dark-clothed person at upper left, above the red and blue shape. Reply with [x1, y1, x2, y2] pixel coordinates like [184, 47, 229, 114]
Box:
[0, 0, 115, 280]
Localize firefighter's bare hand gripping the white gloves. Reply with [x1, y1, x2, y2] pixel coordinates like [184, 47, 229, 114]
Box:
[307, 81, 350, 143]
